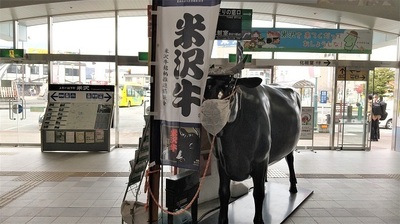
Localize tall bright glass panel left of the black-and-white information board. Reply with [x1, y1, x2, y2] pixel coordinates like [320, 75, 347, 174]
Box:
[0, 63, 47, 145]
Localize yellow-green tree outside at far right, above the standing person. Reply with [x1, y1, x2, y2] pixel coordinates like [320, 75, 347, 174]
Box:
[368, 68, 395, 96]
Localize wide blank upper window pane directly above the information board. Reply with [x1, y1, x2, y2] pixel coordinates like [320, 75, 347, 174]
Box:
[52, 14, 115, 55]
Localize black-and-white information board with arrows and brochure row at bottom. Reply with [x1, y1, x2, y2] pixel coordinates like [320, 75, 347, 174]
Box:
[41, 85, 114, 151]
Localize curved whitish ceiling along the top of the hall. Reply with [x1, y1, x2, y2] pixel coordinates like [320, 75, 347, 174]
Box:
[0, 0, 400, 35]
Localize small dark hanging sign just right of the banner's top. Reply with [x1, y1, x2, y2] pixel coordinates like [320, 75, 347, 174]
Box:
[215, 8, 253, 40]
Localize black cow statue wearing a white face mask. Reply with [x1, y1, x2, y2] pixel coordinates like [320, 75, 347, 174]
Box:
[202, 61, 301, 224]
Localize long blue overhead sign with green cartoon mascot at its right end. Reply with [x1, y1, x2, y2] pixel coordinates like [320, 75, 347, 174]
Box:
[244, 28, 372, 54]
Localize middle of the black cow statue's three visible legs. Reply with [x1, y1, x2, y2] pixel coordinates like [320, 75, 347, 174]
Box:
[252, 162, 268, 224]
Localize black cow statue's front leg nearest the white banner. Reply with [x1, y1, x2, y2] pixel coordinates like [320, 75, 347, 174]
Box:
[218, 163, 231, 224]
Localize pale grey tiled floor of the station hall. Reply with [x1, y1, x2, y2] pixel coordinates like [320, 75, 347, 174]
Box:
[0, 148, 400, 224]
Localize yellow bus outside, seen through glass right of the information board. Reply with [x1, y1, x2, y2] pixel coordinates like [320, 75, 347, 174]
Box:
[119, 83, 144, 107]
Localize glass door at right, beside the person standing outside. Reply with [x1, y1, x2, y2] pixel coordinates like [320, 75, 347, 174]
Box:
[334, 67, 369, 150]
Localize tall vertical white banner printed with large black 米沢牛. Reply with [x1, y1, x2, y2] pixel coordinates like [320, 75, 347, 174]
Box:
[155, 0, 220, 170]
